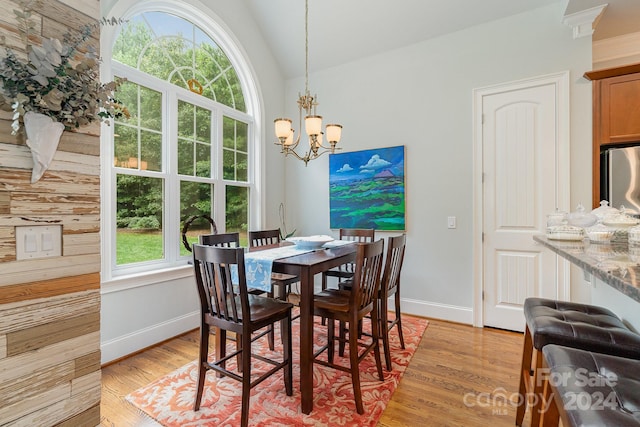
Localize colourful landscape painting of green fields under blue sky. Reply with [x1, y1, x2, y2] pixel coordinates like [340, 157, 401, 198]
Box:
[329, 145, 405, 231]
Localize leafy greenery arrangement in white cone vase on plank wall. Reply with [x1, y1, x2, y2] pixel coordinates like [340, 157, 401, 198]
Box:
[0, 0, 129, 182]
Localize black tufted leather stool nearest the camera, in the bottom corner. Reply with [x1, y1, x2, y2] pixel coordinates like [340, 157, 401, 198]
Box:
[541, 344, 640, 427]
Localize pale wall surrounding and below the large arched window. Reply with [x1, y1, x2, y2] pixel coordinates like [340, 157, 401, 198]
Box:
[101, 0, 285, 363]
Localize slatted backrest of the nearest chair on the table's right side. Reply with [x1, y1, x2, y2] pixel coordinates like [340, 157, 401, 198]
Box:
[351, 239, 384, 310]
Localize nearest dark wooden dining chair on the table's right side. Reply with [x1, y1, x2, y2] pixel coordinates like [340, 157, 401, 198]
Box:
[313, 240, 384, 414]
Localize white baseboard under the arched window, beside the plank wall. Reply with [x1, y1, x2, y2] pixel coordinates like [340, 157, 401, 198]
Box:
[100, 311, 200, 364]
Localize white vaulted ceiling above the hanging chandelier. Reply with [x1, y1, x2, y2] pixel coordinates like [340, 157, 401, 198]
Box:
[245, 0, 640, 78]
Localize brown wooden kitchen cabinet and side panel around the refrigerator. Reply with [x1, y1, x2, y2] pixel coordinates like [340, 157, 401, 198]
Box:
[585, 64, 640, 208]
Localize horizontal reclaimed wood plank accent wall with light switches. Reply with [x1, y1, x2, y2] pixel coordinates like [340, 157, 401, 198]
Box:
[0, 0, 101, 426]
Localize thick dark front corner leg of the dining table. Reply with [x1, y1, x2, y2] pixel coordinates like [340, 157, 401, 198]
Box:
[298, 269, 314, 414]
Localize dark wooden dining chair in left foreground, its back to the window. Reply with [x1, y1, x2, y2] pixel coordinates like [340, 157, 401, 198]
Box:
[193, 245, 293, 427]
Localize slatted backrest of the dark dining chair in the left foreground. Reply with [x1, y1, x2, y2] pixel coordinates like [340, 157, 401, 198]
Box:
[193, 245, 249, 327]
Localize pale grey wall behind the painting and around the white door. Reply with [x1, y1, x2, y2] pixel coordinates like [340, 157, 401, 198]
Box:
[286, 3, 591, 323]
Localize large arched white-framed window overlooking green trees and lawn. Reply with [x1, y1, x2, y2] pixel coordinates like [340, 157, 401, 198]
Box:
[103, 2, 258, 279]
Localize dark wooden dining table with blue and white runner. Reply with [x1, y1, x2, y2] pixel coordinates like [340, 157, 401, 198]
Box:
[260, 242, 356, 414]
